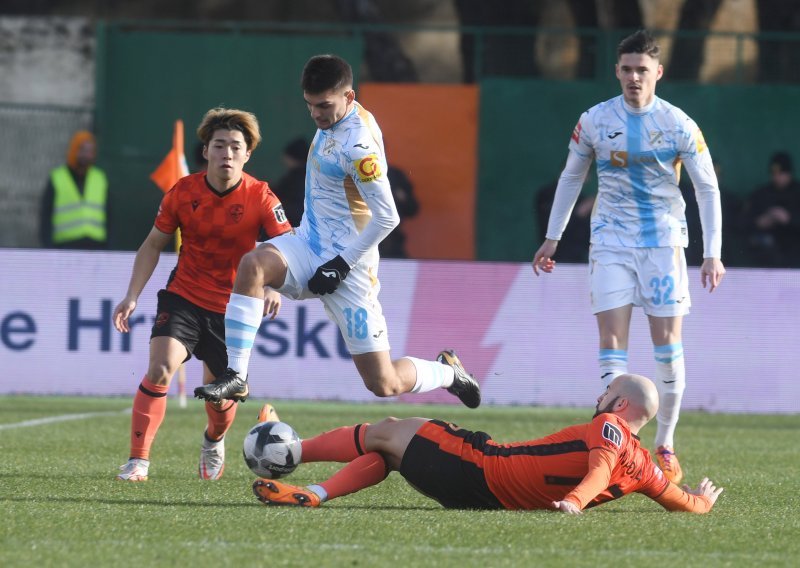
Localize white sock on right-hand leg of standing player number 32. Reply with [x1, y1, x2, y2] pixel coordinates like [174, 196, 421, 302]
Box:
[653, 343, 686, 448]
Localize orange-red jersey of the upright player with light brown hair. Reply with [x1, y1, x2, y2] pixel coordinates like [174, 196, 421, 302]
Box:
[155, 172, 292, 313]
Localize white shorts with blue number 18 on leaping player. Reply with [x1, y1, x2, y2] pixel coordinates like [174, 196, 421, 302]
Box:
[268, 233, 390, 355]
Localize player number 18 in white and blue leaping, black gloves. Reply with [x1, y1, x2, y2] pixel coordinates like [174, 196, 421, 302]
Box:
[195, 55, 481, 408]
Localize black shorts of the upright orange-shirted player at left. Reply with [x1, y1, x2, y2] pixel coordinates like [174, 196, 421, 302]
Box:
[150, 290, 228, 377]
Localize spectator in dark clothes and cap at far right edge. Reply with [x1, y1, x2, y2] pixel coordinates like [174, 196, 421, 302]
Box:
[745, 152, 800, 268]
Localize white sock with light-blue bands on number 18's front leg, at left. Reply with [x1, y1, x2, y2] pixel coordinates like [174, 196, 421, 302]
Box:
[225, 294, 264, 378]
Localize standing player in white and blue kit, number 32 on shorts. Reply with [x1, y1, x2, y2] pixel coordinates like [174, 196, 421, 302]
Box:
[532, 30, 725, 483]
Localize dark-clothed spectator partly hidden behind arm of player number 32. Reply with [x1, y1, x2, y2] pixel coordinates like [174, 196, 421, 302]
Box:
[533, 180, 594, 263]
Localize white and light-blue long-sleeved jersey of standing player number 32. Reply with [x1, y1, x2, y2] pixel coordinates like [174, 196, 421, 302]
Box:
[547, 95, 722, 258]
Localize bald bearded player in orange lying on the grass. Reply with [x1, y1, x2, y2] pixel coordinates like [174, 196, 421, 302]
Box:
[253, 374, 722, 514]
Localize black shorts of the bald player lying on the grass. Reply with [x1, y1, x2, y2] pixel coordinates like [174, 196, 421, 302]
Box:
[400, 420, 504, 509]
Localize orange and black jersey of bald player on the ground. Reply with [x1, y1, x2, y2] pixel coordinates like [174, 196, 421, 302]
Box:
[417, 414, 711, 513]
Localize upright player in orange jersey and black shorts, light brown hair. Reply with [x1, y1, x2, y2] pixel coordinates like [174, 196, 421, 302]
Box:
[113, 108, 292, 481]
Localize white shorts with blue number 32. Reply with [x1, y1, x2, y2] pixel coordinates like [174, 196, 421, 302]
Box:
[589, 245, 692, 317]
